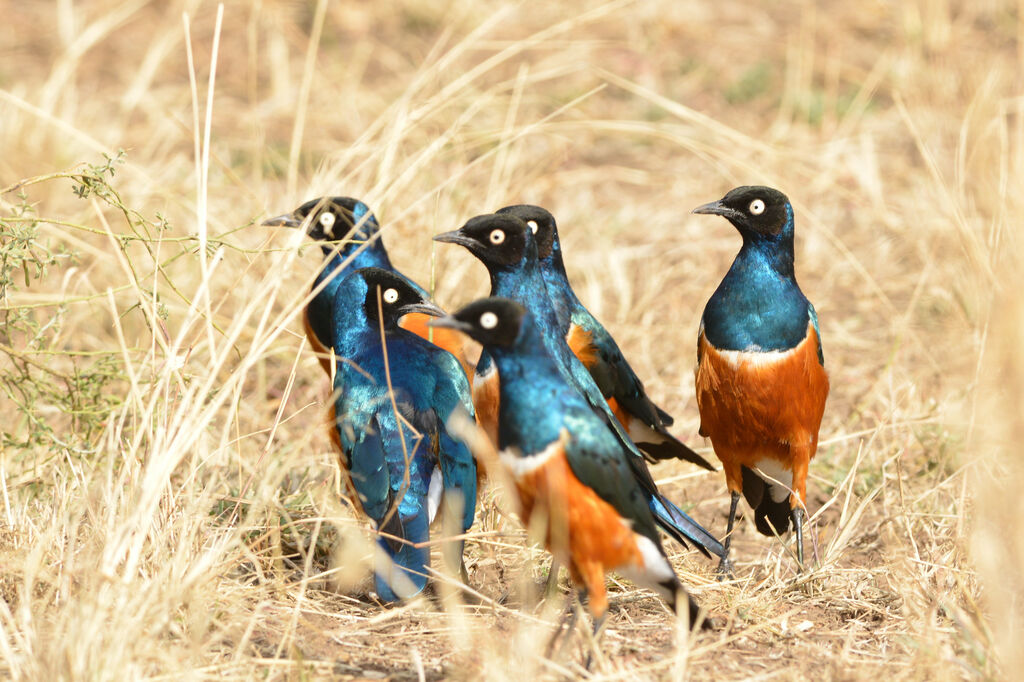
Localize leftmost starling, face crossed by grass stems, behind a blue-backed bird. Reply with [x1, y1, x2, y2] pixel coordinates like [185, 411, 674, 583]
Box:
[262, 197, 473, 377]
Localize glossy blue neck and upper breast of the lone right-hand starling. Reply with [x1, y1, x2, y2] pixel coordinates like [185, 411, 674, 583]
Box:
[702, 206, 810, 352]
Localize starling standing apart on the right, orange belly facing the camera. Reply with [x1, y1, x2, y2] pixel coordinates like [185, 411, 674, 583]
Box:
[693, 186, 828, 574]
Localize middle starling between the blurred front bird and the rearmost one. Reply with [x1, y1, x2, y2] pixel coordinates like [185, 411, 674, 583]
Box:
[434, 214, 724, 556]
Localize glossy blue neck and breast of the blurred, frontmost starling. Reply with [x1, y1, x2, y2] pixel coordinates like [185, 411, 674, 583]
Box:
[486, 313, 574, 455]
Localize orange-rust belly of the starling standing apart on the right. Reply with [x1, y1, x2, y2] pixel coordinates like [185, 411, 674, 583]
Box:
[695, 325, 828, 495]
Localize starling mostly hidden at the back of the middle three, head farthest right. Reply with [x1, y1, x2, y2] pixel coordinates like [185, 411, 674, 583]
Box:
[497, 204, 716, 471]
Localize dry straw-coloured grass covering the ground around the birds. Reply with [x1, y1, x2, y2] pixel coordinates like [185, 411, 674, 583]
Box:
[0, 0, 1024, 680]
